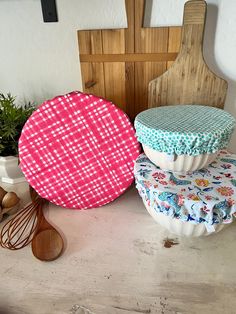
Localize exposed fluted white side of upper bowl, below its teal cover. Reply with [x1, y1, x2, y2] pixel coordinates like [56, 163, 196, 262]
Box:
[143, 145, 217, 173]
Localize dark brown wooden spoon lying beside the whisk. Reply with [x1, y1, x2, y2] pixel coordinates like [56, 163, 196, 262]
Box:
[31, 200, 64, 261]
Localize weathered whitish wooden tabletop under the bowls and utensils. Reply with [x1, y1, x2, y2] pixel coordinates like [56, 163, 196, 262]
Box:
[0, 184, 236, 314]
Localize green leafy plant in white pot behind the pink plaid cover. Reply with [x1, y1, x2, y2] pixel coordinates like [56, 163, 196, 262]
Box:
[0, 93, 35, 183]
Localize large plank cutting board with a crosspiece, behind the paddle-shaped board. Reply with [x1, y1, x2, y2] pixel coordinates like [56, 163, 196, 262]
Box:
[78, 0, 181, 119]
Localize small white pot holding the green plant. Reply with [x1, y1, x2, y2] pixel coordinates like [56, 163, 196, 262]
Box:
[0, 156, 26, 184]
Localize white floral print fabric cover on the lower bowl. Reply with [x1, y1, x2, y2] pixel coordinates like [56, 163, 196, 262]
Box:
[134, 151, 236, 231]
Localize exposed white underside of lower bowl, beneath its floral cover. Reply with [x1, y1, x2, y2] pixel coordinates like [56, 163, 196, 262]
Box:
[144, 204, 228, 237]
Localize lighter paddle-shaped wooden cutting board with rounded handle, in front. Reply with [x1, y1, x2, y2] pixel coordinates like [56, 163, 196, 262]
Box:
[148, 0, 228, 108]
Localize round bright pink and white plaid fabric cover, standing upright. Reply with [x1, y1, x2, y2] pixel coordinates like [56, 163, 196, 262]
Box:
[19, 92, 140, 209]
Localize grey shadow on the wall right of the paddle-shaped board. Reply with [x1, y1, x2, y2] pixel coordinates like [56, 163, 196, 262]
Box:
[203, 4, 236, 153]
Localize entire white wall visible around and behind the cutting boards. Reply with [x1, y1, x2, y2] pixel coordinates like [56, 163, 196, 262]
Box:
[0, 0, 236, 152]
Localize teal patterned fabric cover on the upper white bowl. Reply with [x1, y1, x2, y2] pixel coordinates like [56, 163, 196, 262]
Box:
[134, 105, 236, 156]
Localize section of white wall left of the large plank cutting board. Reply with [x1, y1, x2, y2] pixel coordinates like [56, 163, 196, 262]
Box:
[0, 0, 126, 103]
